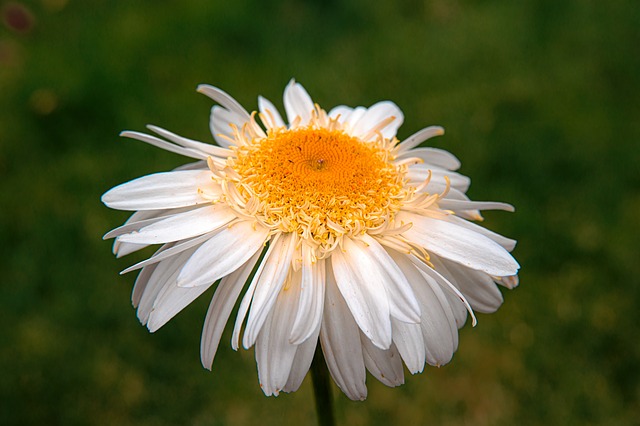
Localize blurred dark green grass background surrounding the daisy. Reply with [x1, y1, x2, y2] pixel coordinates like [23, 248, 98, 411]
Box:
[0, 0, 640, 426]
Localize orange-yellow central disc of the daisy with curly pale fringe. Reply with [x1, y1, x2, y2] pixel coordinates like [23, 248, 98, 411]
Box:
[222, 121, 407, 258]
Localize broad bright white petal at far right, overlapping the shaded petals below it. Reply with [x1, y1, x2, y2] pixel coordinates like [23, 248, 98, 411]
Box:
[397, 212, 520, 276]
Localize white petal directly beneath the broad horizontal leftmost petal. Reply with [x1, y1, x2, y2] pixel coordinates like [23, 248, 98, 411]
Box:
[120, 204, 237, 244]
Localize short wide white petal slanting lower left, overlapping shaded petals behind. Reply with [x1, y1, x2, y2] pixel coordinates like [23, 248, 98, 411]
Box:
[178, 221, 269, 287]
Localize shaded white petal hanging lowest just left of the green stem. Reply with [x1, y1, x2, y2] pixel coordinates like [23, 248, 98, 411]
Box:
[255, 272, 300, 396]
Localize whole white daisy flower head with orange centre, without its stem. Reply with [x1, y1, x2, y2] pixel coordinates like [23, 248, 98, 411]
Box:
[102, 80, 519, 400]
